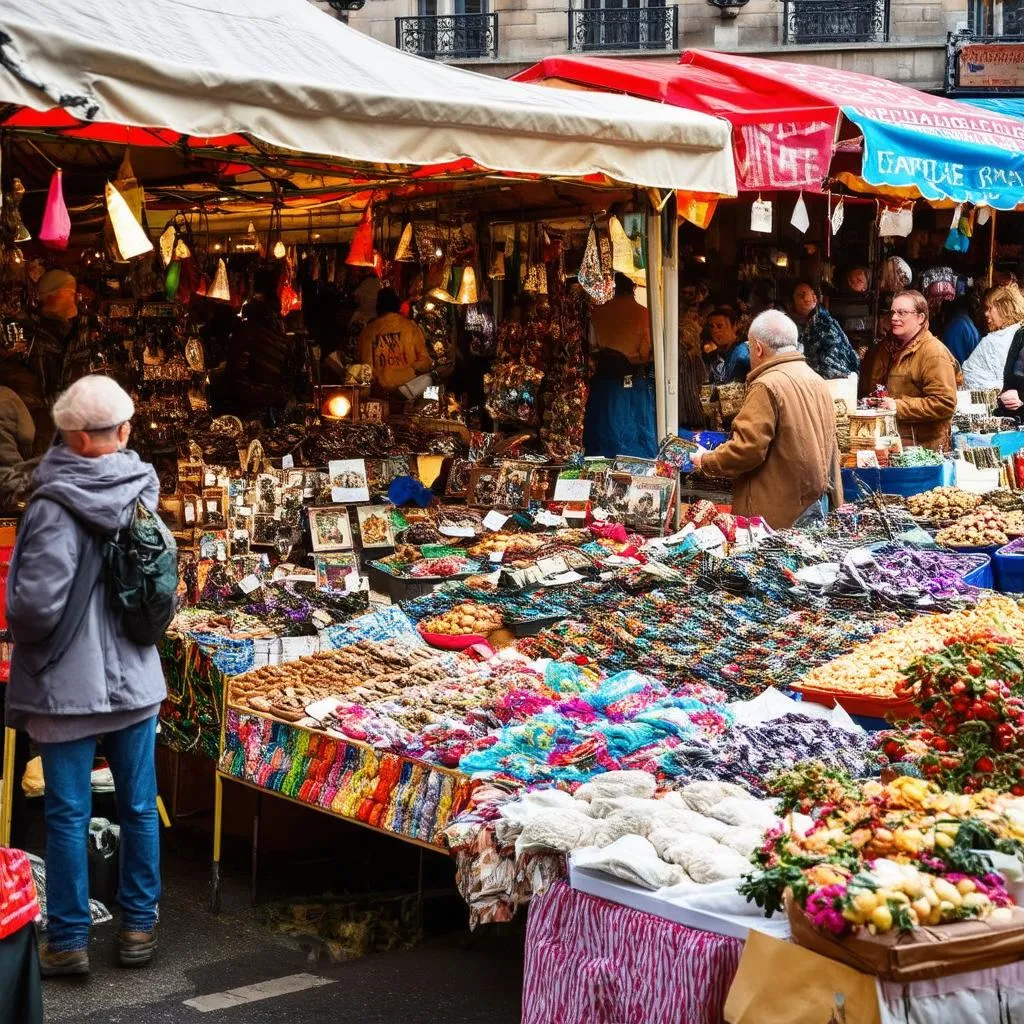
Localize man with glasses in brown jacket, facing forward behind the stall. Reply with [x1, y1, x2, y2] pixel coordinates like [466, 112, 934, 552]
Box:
[860, 292, 958, 452]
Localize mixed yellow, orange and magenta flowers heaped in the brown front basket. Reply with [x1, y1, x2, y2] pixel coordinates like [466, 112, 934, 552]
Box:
[739, 764, 1024, 934]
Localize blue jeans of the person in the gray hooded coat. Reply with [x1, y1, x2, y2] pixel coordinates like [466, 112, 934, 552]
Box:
[39, 716, 160, 951]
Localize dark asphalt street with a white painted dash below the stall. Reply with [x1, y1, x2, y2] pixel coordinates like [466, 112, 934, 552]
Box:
[24, 806, 522, 1024]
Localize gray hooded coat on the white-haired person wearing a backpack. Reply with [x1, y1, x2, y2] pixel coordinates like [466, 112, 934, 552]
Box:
[7, 446, 167, 727]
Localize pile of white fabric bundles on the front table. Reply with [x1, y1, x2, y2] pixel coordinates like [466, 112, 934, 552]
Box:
[495, 771, 779, 889]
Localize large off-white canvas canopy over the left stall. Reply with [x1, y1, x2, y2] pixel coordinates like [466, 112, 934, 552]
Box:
[0, 0, 736, 195]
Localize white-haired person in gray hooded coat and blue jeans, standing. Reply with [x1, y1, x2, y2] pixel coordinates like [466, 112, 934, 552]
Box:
[7, 376, 166, 976]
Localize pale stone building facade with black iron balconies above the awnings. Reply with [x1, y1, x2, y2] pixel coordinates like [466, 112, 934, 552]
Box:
[313, 0, 1024, 92]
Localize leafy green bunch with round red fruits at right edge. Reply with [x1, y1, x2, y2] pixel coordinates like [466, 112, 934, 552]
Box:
[878, 631, 1024, 796]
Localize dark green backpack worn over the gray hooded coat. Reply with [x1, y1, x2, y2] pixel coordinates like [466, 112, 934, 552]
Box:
[103, 502, 178, 645]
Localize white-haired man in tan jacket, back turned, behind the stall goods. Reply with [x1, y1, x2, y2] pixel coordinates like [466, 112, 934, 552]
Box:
[691, 309, 843, 529]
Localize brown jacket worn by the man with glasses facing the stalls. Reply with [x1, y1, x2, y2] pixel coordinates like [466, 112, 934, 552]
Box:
[860, 328, 959, 452]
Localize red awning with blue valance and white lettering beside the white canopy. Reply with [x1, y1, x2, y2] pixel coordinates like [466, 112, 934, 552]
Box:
[517, 50, 1024, 209]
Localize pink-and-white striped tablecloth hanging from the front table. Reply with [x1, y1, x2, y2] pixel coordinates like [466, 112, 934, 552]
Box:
[522, 882, 743, 1024]
